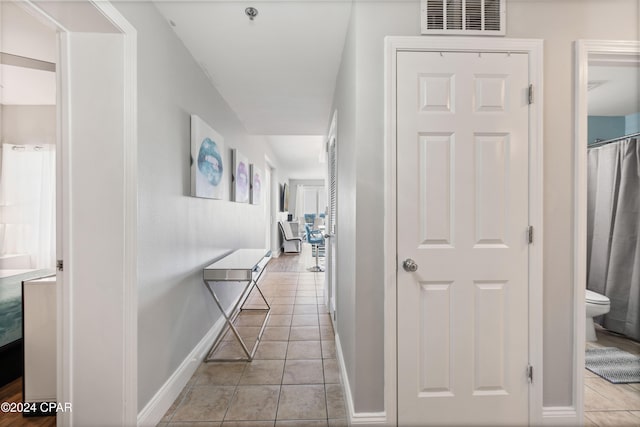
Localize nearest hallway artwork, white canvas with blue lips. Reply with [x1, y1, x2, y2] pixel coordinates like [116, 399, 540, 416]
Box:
[191, 114, 227, 199]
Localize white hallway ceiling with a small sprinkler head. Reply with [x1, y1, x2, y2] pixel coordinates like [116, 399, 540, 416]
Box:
[155, 0, 351, 179]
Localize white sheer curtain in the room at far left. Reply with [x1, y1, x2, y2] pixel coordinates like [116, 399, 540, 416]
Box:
[0, 144, 56, 268]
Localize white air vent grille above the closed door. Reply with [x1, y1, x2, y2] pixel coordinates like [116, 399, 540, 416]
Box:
[420, 0, 506, 36]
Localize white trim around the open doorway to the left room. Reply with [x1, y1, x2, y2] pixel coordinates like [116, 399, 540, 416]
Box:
[23, 0, 138, 425]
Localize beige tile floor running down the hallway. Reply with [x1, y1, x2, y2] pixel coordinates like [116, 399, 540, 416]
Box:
[159, 251, 347, 427]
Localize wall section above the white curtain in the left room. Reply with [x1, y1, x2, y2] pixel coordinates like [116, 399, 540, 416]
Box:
[0, 105, 56, 144]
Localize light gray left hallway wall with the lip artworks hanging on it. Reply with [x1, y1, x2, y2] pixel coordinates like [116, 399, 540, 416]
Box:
[114, 2, 286, 409]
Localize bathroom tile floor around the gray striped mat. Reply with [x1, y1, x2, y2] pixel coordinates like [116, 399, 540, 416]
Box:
[584, 326, 640, 427]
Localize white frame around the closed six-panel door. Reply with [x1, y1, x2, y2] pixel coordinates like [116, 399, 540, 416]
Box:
[384, 37, 543, 425]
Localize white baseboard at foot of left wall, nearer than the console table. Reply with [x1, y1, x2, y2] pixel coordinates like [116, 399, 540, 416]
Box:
[138, 316, 224, 426]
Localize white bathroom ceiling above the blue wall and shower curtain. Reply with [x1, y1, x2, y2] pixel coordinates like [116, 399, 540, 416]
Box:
[588, 63, 640, 116]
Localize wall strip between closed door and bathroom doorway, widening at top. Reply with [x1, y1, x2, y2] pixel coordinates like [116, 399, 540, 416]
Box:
[507, 0, 640, 406]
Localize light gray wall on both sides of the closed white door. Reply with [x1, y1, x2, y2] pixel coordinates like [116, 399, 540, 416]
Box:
[334, 0, 639, 412]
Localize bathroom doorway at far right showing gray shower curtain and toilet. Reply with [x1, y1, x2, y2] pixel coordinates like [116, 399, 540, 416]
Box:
[574, 41, 640, 425]
